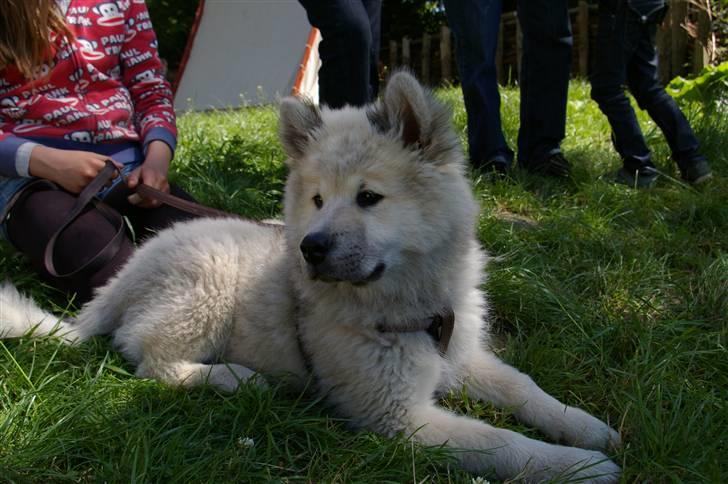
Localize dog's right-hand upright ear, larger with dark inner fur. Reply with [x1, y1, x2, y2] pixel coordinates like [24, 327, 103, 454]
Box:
[368, 71, 459, 163]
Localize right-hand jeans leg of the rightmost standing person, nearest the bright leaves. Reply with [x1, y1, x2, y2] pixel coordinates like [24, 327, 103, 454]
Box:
[627, 18, 710, 182]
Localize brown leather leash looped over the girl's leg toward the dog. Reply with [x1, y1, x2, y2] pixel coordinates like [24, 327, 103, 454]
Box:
[43, 160, 243, 277]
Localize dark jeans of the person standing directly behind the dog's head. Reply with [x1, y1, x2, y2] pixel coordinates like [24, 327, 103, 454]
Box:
[299, 0, 382, 108]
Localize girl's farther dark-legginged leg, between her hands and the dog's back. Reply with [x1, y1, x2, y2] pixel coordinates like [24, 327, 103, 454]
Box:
[104, 184, 197, 242]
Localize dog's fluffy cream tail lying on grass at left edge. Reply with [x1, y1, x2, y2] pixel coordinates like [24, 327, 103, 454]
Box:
[0, 282, 102, 344]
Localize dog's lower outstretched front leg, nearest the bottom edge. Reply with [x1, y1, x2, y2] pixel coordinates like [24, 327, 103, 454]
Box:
[408, 405, 620, 483]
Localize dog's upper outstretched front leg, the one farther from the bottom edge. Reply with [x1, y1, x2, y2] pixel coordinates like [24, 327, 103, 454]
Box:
[465, 350, 620, 450]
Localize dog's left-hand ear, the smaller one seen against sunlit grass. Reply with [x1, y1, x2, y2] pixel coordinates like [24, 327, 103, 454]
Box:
[278, 97, 323, 160]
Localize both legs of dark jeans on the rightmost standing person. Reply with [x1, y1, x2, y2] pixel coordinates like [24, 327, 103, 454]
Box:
[590, 0, 703, 171]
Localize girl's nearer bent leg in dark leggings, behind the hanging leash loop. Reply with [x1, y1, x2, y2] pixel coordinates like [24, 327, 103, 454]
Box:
[7, 190, 134, 303]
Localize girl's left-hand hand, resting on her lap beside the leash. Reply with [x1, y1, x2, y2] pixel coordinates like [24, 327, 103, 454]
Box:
[28, 145, 121, 193]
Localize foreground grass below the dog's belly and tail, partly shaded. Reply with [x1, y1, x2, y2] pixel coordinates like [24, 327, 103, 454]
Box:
[0, 338, 467, 482]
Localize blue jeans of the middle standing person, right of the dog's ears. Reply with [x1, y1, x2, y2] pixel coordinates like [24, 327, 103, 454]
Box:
[445, 0, 572, 168]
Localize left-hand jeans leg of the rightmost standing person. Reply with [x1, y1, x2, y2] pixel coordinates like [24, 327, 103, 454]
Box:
[589, 0, 654, 173]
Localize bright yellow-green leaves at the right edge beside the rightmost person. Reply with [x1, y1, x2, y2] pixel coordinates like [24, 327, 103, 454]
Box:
[667, 61, 728, 113]
